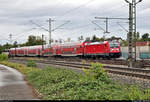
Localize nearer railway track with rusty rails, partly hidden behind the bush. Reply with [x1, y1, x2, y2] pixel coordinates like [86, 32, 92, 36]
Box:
[8, 59, 150, 81]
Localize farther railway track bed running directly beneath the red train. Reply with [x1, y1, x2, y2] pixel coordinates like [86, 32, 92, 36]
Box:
[11, 57, 150, 68]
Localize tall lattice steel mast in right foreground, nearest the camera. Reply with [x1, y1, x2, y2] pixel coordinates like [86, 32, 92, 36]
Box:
[125, 0, 142, 67]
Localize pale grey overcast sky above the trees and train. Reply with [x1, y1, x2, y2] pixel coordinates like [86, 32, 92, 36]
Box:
[0, 0, 150, 44]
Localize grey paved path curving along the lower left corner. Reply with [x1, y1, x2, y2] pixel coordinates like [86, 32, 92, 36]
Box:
[0, 65, 39, 100]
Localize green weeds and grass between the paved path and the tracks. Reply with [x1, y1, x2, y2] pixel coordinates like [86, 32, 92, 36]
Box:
[0, 62, 150, 100]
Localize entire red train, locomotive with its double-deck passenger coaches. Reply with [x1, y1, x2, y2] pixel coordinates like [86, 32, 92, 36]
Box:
[9, 41, 121, 58]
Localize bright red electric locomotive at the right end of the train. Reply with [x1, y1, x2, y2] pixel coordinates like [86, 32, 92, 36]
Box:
[84, 41, 121, 58]
